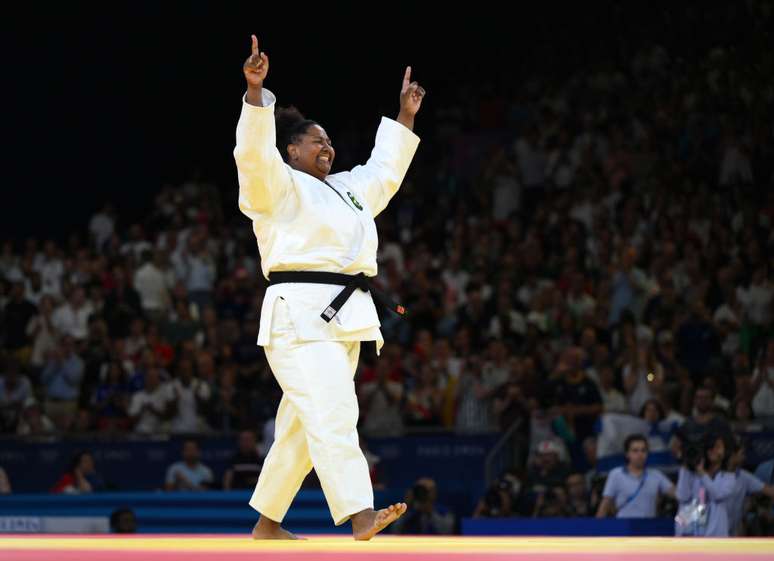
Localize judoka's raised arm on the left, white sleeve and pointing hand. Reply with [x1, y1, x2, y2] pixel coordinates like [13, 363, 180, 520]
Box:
[234, 35, 293, 215]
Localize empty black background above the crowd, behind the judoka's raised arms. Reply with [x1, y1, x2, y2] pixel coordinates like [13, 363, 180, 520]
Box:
[0, 1, 747, 239]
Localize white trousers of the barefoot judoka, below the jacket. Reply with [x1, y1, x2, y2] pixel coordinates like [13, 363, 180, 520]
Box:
[250, 298, 374, 526]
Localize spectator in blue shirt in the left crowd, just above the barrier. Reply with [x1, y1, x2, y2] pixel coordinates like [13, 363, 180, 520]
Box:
[40, 335, 84, 431]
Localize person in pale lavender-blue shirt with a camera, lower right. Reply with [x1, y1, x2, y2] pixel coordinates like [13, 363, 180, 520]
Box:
[675, 434, 736, 536]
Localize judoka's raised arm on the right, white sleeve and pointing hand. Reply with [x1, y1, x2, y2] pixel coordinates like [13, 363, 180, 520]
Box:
[334, 66, 425, 216]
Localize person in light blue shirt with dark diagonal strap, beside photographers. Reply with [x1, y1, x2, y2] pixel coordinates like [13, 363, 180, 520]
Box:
[597, 434, 675, 518]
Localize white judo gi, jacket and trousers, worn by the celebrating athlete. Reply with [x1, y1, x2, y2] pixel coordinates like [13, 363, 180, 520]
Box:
[234, 89, 419, 525]
